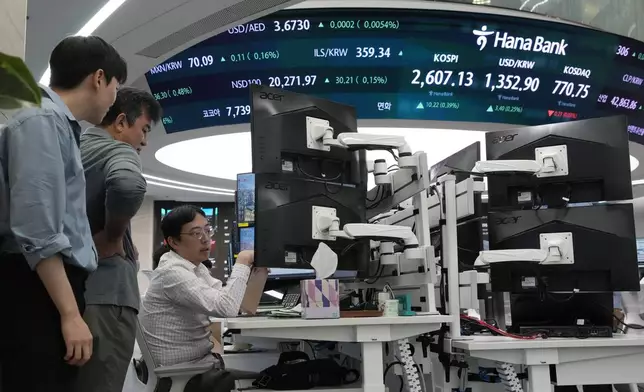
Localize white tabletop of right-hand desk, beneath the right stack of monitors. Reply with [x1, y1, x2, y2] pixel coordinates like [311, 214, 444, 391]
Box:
[452, 335, 644, 352]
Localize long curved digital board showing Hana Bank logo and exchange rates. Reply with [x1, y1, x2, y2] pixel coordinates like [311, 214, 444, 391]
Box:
[146, 8, 644, 141]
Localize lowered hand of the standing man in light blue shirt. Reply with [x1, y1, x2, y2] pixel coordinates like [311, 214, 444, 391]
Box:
[60, 313, 93, 366]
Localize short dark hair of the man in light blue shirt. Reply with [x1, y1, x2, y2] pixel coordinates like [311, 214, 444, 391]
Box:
[49, 36, 127, 90]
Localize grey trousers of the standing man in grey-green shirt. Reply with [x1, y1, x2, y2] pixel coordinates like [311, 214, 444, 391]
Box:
[76, 305, 137, 392]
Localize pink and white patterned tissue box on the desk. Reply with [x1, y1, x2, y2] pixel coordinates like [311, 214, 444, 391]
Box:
[300, 279, 340, 319]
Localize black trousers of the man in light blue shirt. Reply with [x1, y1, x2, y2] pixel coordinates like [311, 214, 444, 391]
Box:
[0, 254, 87, 392]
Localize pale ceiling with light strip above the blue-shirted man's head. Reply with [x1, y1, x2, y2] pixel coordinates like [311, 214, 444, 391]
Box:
[26, 0, 299, 86]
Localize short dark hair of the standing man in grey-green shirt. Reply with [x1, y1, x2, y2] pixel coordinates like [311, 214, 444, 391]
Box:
[101, 87, 161, 126]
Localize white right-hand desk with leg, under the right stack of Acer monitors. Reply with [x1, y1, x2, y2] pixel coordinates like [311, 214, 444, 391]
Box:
[452, 335, 644, 392]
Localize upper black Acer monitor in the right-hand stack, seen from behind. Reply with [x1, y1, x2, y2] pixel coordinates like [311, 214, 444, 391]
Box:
[486, 116, 633, 209]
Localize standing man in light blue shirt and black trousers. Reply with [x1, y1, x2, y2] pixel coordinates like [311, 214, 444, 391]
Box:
[0, 37, 127, 392]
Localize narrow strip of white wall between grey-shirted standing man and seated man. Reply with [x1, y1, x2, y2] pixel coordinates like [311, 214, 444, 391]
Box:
[131, 196, 154, 294]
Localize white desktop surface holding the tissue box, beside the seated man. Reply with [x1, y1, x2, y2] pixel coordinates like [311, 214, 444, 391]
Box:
[226, 314, 452, 329]
